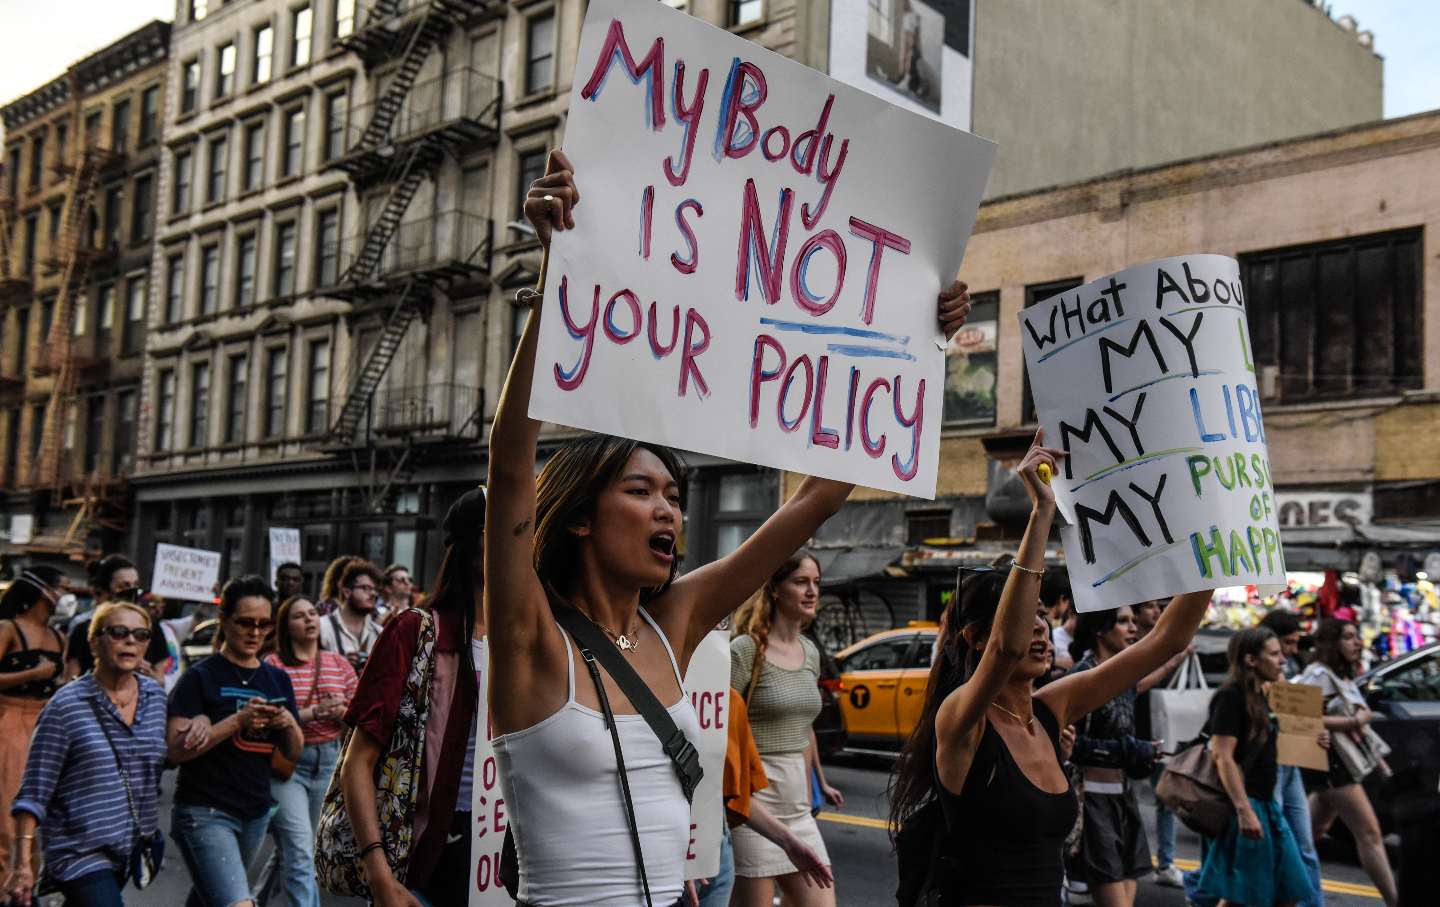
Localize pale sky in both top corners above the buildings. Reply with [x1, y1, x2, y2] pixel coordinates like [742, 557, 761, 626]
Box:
[0, 0, 1440, 132]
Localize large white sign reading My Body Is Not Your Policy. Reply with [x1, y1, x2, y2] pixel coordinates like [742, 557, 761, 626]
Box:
[530, 0, 995, 497]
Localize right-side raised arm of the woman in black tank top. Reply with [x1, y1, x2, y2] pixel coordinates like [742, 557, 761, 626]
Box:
[1035, 589, 1214, 724]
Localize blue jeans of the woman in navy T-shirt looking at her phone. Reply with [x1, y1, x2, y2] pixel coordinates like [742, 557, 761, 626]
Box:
[170, 803, 269, 907]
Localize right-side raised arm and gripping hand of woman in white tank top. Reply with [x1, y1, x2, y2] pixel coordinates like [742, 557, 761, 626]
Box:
[657, 281, 971, 659]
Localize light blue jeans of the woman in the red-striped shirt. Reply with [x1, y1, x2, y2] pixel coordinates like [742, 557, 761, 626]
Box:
[269, 740, 340, 907]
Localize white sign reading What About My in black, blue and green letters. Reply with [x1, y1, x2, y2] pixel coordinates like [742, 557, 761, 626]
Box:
[1020, 255, 1284, 610]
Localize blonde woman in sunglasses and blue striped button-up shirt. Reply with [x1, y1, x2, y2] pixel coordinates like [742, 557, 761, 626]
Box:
[4, 600, 168, 907]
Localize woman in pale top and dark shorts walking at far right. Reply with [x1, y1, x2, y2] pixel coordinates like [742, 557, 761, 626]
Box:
[1296, 618, 1400, 907]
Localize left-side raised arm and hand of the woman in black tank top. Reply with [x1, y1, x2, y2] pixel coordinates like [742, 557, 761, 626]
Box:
[935, 429, 1064, 760]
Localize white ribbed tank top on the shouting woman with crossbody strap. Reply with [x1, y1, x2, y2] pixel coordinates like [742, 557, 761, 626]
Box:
[494, 608, 700, 907]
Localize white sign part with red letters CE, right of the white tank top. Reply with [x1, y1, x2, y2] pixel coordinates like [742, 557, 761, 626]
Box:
[685, 629, 730, 878]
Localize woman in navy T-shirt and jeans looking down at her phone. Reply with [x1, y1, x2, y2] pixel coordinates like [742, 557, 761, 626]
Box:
[167, 576, 304, 907]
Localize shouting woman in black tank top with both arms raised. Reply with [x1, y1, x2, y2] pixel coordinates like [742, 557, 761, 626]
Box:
[891, 430, 1211, 907]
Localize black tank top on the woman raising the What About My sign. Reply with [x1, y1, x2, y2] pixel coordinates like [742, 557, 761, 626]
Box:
[936, 700, 1079, 907]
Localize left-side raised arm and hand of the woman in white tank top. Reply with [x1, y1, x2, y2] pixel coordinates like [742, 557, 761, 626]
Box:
[485, 150, 580, 728]
